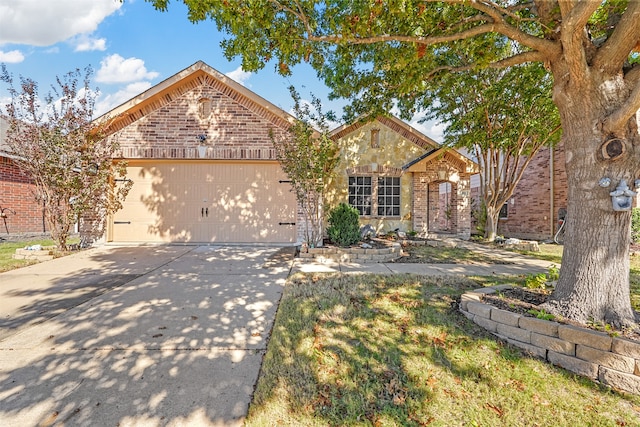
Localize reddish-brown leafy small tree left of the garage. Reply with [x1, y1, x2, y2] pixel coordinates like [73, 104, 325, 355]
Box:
[1, 66, 132, 250]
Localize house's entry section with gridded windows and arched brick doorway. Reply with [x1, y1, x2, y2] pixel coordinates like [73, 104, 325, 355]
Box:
[326, 117, 478, 238]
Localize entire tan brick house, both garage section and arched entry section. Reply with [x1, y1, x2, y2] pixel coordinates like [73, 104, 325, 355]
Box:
[99, 62, 477, 244]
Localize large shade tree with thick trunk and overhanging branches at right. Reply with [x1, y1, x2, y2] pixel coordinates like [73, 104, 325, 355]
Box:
[148, 0, 640, 325]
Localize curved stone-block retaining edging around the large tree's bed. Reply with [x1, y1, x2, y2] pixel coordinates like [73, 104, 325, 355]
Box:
[460, 285, 640, 394]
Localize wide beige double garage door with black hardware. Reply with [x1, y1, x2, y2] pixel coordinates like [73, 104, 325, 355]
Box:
[109, 162, 296, 243]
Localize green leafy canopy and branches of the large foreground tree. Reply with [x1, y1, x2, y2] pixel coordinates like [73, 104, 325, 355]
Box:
[147, 0, 640, 123]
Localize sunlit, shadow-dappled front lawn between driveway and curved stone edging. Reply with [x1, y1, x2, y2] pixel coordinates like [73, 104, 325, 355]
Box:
[246, 274, 640, 426]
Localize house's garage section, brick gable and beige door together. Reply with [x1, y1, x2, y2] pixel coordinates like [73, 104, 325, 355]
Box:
[104, 62, 302, 244]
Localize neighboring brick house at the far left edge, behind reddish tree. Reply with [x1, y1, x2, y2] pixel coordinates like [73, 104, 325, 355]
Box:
[0, 117, 47, 237]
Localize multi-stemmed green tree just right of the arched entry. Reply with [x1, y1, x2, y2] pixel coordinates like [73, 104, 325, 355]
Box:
[421, 64, 560, 241]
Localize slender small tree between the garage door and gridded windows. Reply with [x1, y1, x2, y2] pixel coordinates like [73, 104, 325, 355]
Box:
[269, 86, 339, 247]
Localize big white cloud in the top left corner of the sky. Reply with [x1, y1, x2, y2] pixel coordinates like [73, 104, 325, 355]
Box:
[0, 0, 122, 46]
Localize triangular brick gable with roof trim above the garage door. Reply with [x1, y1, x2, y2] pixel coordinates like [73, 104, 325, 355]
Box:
[99, 62, 294, 159]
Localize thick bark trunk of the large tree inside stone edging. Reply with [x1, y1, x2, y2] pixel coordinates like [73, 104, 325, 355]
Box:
[547, 68, 639, 326]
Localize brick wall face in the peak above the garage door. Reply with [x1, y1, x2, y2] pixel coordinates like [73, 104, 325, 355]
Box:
[110, 79, 288, 160]
